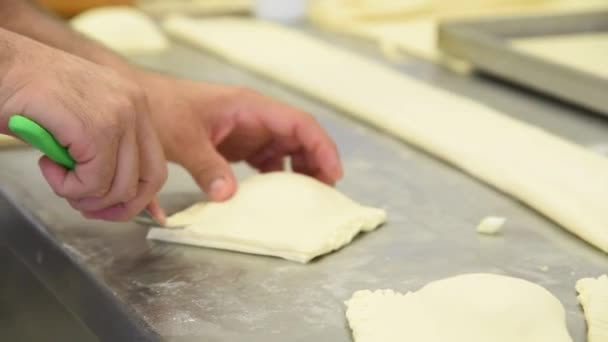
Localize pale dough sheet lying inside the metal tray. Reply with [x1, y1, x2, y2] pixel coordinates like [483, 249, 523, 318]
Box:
[510, 32, 608, 79]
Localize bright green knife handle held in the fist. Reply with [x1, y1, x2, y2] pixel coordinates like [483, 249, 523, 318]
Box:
[8, 115, 76, 170]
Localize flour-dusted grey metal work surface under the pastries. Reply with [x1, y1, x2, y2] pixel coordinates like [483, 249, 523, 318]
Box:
[0, 28, 608, 342]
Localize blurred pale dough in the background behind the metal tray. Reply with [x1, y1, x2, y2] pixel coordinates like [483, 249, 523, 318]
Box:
[311, 0, 608, 63]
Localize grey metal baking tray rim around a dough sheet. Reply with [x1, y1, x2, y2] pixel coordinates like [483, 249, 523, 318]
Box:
[438, 11, 608, 116]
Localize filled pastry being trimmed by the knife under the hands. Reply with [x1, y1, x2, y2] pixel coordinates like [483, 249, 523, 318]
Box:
[148, 172, 386, 263]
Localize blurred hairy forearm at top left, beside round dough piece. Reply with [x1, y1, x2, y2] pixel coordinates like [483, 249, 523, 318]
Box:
[0, 0, 132, 72]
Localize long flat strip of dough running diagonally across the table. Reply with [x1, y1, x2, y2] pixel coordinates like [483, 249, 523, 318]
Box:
[164, 17, 608, 252]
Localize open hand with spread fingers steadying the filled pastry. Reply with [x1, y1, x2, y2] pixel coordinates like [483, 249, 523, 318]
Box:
[139, 72, 343, 201]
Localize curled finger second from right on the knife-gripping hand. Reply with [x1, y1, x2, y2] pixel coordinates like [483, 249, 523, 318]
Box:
[69, 129, 140, 212]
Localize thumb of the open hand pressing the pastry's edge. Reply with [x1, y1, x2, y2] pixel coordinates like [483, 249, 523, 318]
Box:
[183, 144, 237, 201]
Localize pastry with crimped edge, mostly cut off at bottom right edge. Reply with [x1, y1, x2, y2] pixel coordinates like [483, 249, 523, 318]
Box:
[576, 275, 608, 342]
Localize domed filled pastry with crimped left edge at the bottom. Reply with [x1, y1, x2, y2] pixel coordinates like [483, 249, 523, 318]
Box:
[346, 274, 576, 342]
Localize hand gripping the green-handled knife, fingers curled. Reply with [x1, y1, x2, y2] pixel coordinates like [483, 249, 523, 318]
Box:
[0, 35, 167, 221]
